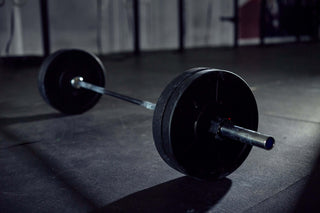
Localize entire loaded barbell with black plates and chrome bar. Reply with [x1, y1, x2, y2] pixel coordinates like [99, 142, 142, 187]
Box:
[38, 49, 275, 180]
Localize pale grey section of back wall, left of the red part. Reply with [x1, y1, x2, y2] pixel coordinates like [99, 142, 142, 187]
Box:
[0, 0, 233, 56]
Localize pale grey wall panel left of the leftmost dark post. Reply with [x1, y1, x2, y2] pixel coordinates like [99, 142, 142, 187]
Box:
[0, 0, 42, 56]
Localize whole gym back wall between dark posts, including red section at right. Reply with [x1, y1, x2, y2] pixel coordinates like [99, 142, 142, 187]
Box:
[0, 0, 320, 56]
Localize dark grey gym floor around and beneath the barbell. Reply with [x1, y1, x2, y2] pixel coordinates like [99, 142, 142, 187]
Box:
[0, 43, 320, 213]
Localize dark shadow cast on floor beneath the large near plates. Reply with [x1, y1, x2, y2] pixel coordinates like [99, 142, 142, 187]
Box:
[92, 176, 232, 213]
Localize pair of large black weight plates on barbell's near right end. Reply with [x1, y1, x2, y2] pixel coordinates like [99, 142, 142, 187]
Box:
[153, 69, 258, 180]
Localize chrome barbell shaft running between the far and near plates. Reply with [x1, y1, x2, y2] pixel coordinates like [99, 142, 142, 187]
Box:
[71, 76, 156, 110]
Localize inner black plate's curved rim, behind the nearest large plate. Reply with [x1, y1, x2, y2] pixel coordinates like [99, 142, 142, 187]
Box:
[152, 67, 207, 172]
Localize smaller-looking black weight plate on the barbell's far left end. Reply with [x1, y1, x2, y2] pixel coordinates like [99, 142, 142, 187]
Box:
[38, 49, 105, 114]
